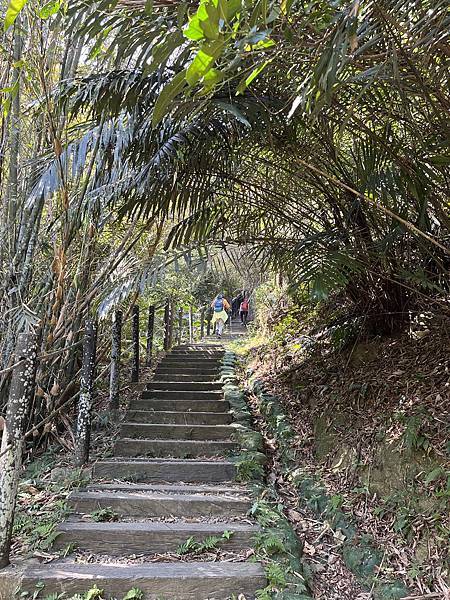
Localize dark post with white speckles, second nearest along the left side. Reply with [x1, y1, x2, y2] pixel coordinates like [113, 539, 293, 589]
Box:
[75, 319, 96, 467]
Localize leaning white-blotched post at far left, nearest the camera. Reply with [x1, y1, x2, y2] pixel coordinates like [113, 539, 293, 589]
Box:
[0, 333, 37, 569]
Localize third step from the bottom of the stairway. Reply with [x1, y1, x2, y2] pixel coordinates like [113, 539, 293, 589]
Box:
[68, 491, 251, 518]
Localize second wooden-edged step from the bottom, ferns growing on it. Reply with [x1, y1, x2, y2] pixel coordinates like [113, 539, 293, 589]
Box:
[54, 521, 259, 556]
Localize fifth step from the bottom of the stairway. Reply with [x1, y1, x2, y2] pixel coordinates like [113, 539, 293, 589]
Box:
[114, 438, 238, 458]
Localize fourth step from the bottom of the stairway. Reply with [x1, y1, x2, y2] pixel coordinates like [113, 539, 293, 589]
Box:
[93, 458, 236, 483]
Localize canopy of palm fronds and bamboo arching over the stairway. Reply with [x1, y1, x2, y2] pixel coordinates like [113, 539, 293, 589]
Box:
[0, 0, 450, 446]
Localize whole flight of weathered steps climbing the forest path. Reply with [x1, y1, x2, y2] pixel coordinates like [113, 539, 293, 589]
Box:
[22, 344, 265, 600]
